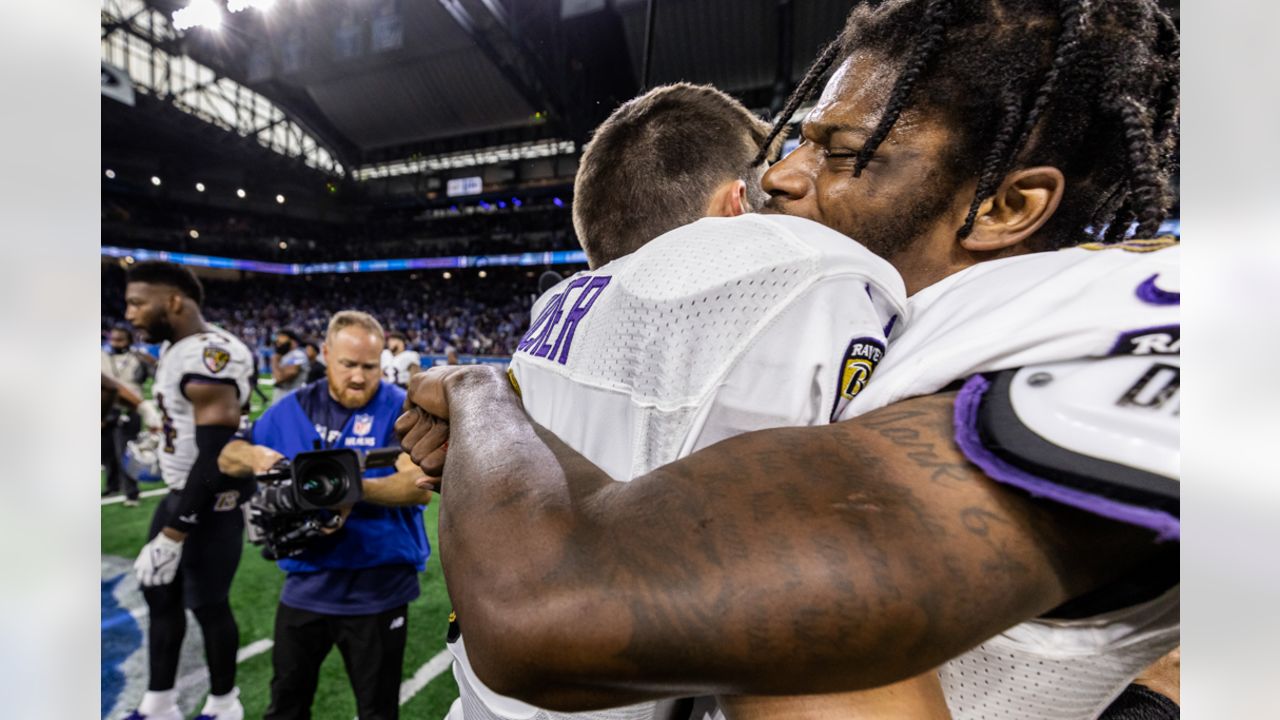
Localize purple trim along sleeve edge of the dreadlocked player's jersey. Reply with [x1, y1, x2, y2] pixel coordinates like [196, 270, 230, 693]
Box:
[955, 375, 1181, 541]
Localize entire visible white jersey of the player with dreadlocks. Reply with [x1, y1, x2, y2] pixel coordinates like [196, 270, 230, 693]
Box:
[845, 240, 1181, 720]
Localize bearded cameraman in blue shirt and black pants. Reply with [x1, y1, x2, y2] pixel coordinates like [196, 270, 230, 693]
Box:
[218, 310, 430, 720]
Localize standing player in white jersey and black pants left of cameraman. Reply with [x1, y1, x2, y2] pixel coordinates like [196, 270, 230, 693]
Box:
[124, 263, 255, 720]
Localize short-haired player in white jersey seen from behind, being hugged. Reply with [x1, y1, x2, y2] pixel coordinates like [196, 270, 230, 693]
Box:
[424, 83, 947, 720]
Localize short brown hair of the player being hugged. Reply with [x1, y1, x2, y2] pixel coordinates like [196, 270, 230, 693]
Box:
[573, 82, 769, 268]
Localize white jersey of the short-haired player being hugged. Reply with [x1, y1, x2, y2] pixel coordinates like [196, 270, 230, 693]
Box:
[449, 210, 905, 720]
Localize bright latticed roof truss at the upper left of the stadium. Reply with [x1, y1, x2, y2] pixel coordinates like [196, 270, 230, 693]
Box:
[102, 0, 346, 177]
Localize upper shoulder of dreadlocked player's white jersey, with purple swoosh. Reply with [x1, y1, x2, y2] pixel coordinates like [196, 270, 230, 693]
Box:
[841, 240, 1181, 419]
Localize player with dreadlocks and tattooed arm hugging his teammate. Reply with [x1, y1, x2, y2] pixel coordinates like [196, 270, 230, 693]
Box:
[402, 0, 1180, 720]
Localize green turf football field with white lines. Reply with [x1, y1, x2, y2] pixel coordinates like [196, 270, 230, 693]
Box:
[101, 379, 458, 720]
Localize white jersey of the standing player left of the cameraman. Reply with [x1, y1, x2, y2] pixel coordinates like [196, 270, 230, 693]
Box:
[151, 325, 253, 489]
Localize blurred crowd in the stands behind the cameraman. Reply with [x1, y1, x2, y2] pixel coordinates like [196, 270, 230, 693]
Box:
[102, 263, 560, 359]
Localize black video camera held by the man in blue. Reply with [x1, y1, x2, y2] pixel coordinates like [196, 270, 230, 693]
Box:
[246, 447, 401, 560]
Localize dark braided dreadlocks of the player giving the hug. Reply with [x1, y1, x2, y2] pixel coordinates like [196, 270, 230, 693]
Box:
[758, 0, 1179, 249]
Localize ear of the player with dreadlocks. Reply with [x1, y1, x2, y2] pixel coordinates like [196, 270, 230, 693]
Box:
[960, 165, 1066, 252]
